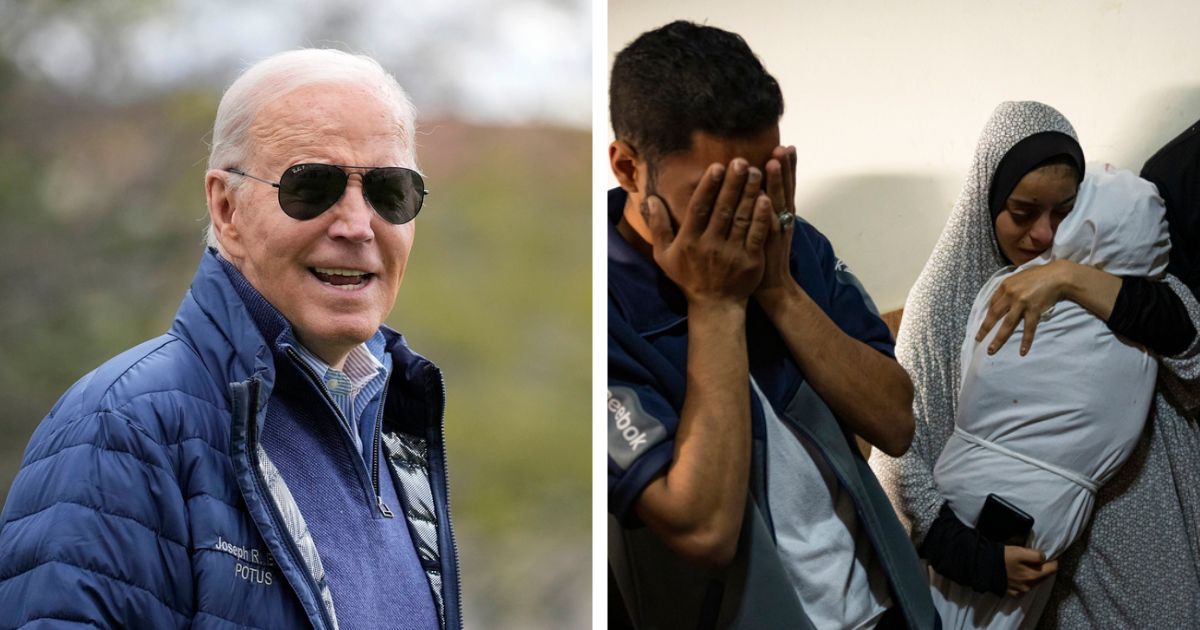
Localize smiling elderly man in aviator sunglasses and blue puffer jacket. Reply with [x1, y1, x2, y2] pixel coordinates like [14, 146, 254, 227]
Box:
[0, 49, 461, 629]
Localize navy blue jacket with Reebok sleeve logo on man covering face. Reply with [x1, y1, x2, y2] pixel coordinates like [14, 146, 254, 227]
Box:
[608, 188, 940, 629]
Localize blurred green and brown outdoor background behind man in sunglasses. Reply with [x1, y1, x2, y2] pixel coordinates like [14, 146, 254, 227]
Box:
[0, 0, 592, 629]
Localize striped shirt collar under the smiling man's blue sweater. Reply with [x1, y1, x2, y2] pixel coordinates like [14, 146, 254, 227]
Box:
[287, 331, 391, 461]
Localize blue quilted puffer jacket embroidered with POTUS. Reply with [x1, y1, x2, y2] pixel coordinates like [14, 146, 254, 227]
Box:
[0, 250, 462, 629]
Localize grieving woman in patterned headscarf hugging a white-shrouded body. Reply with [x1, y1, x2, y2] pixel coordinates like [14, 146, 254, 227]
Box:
[871, 102, 1200, 628]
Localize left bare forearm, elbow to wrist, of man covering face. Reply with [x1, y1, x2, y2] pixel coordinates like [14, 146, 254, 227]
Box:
[637, 302, 750, 566]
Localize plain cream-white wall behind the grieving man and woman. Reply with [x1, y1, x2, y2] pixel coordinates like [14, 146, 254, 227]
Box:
[605, 0, 1200, 311]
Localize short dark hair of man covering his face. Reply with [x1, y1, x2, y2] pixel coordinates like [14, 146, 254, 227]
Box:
[608, 22, 784, 163]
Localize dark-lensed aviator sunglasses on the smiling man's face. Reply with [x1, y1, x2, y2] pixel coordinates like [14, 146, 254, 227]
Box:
[224, 164, 430, 226]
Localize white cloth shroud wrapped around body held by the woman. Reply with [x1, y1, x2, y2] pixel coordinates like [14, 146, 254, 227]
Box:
[934, 167, 1170, 629]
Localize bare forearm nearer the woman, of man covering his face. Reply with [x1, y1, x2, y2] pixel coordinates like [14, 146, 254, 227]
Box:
[757, 282, 913, 456]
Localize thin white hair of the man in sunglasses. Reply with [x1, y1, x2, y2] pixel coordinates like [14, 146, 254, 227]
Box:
[205, 48, 416, 247]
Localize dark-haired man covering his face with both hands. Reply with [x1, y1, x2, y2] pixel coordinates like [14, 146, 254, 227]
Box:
[607, 22, 936, 628]
